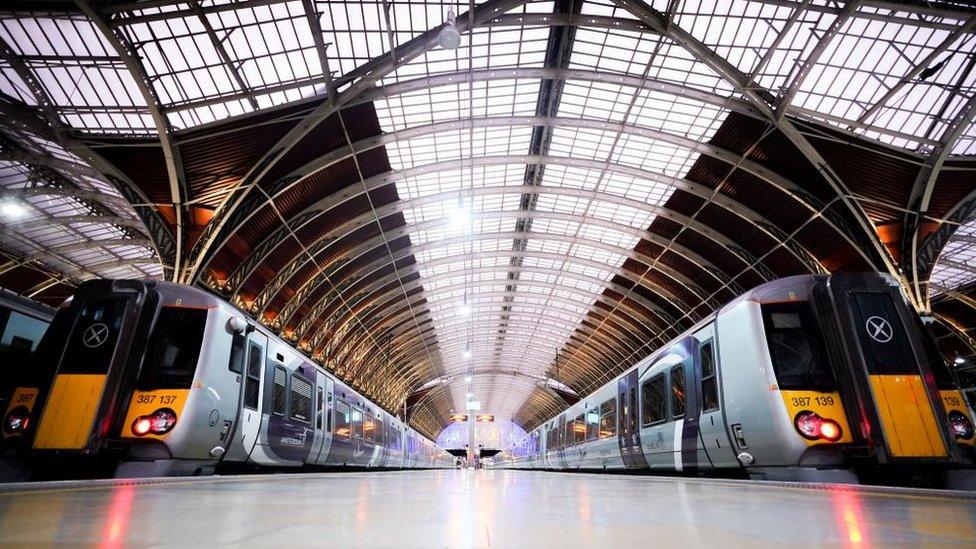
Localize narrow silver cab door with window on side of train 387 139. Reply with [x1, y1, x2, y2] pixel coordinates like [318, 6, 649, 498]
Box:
[695, 324, 739, 467]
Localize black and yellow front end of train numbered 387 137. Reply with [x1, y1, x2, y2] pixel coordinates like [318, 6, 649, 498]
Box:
[3, 280, 218, 473]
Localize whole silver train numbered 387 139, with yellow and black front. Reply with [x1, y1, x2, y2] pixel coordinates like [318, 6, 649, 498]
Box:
[490, 274, 974, 487]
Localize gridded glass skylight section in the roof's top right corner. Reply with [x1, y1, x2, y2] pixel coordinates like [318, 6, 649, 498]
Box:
[793, 6, 976, 149]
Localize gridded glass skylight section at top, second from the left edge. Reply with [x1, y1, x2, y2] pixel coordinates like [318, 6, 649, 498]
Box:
[120, 0, 322, 128]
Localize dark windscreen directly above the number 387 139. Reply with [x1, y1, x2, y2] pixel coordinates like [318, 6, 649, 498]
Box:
[762, 302, 837, 391]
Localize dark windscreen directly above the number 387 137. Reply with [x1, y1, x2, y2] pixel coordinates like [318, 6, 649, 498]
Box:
[138, 307, 207, 391]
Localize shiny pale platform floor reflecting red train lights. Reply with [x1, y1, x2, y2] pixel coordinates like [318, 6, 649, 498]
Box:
[0, 470, 976, 548]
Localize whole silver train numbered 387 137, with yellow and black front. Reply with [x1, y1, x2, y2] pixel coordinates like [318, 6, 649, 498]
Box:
[0, 280, 454, 476]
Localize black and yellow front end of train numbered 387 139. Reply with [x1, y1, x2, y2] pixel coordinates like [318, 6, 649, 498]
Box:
[746, 274, 976, 487]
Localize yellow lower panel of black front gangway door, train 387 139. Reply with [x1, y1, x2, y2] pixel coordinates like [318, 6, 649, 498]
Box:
[869, 375, 946, 457]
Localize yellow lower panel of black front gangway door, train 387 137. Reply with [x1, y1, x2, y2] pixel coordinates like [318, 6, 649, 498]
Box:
[34, 374, 106, 450]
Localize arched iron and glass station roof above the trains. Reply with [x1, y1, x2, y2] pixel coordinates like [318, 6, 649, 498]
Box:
[0, 0, 976, 436]
